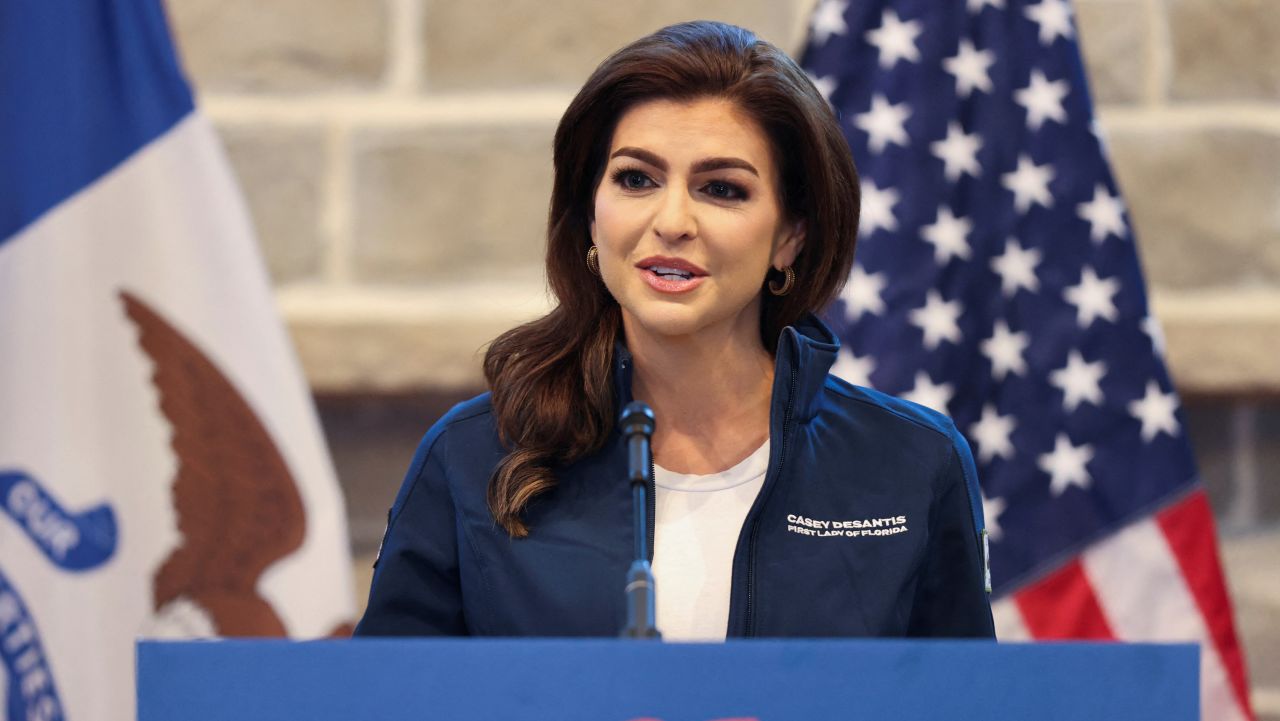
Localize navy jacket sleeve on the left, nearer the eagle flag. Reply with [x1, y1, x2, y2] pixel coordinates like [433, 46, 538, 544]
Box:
[355, 424, 467, 636]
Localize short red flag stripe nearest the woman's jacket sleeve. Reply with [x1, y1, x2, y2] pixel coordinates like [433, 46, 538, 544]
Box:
[1014, 558, 1115, 640]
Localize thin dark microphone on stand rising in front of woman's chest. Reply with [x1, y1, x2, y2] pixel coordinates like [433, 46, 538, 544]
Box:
[618, 401, 662, 639]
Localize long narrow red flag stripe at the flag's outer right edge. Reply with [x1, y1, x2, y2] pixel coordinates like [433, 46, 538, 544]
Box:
[1156, 490, 1253, 718]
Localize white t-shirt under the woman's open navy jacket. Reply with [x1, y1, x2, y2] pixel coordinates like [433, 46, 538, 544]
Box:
[653, 441, 769, 640]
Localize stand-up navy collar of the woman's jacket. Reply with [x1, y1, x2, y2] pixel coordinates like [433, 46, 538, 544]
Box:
[613, 312, 840, 421]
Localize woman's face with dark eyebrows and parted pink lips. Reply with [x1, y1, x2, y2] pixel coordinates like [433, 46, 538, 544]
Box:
[591, 99, 803, 350]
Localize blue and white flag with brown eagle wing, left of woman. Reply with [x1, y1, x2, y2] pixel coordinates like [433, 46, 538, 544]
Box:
[0, 0, 353, 721]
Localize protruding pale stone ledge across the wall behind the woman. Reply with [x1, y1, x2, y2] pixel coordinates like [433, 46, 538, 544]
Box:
[285, 286, 1280, 396]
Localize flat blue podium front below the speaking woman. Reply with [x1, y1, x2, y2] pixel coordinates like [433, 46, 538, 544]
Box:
[137, 639, 1199, 721]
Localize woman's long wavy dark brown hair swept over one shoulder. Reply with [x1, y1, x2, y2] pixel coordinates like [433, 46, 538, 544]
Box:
[484, 22, 859, 538]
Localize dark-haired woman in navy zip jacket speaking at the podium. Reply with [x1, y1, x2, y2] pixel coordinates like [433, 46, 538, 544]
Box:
[357, 22, 993, 639]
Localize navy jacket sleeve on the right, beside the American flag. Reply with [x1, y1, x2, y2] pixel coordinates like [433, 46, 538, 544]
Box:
[908, 429, 996, 639]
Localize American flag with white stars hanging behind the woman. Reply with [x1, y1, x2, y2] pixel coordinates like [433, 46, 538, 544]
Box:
[803, 0, 1252, 718]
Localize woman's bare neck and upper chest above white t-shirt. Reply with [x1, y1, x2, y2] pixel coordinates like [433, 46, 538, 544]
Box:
[625, 315, 773, 474]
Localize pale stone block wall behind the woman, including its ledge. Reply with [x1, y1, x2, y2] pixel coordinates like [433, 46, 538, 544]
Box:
[169, 0, 1280, 394]
